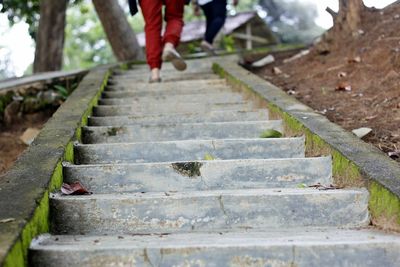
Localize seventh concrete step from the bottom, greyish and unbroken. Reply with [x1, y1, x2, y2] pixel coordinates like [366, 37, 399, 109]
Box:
[93, 102, 254, 116]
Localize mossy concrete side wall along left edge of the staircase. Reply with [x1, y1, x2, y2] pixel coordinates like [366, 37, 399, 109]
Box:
[0, 69, 107, 266]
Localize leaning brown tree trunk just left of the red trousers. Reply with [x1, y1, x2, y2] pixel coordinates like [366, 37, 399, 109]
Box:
[92, 0, 144, 61]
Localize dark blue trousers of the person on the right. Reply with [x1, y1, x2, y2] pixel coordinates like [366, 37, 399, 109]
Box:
[201, 0, 227, 44]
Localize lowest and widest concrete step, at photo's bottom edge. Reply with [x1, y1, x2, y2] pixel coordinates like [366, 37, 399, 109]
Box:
[29, 228, 400, 267]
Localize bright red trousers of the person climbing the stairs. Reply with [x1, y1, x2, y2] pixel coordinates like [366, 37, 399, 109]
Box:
[140, 0, 185, 69]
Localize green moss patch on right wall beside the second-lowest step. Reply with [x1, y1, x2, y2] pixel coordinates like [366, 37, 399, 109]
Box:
[369, 182, 400, 231]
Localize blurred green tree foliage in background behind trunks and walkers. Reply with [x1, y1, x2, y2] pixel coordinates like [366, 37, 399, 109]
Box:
[1, 0, 323, 74]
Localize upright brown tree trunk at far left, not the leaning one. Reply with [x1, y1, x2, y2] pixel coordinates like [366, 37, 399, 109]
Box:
[33, 0, 68, 73]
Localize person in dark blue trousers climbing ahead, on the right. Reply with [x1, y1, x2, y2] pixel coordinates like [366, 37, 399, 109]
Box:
[194, 0, 238, 55]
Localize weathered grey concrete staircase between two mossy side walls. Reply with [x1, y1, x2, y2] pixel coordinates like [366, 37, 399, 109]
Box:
[30, 61, 400, 267]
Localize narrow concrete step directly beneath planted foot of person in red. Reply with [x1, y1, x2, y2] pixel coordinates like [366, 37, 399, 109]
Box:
[106, 78, 227, 92]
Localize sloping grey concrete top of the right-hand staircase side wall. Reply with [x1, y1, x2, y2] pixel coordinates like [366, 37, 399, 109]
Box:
[216, 59, 400, 199]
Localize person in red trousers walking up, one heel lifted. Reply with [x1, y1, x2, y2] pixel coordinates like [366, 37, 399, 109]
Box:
[129, 0, 186, 83]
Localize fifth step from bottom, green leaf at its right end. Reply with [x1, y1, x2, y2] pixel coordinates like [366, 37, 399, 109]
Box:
[82, 120, 283, 144]
